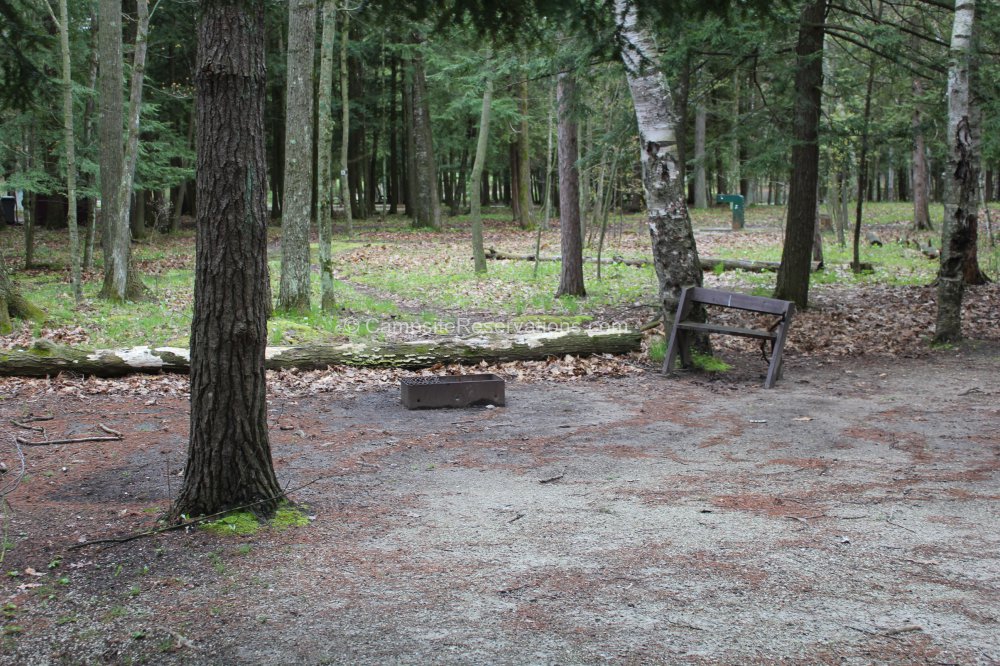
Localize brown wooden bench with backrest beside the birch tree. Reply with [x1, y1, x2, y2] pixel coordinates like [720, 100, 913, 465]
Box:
[663, 287, 795, 388]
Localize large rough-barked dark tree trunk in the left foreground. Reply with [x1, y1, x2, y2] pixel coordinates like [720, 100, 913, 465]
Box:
[171, 0, 282, 518]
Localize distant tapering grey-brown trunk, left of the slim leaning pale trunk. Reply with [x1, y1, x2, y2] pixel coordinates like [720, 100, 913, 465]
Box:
[413, 41, 441, 229]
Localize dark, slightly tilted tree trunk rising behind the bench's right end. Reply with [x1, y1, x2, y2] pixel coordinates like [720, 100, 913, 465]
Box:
[774, 0, 827, 309]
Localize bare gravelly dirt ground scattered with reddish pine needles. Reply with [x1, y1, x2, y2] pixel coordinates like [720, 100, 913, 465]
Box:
[0, 342, 1000, 664]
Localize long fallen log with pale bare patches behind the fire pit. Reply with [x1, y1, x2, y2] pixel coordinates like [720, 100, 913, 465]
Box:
[0, 329, 642, 377]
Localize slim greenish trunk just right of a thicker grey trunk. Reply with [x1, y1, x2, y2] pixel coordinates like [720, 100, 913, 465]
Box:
[316, 0, 337, 313]
